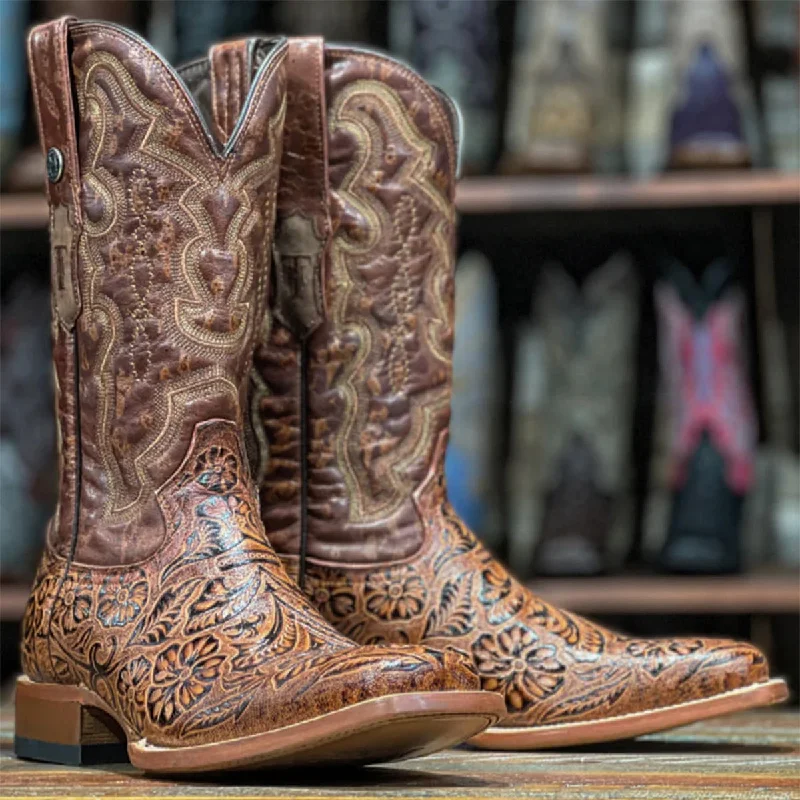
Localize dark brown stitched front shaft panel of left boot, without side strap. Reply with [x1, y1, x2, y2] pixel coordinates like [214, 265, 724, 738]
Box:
[72, 24, 284, 564]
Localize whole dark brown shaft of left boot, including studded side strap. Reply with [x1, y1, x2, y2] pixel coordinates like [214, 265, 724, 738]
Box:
[29, 19, 286, 565]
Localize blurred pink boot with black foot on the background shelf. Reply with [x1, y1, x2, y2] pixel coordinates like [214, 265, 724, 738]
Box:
[655, 259, 758, 574]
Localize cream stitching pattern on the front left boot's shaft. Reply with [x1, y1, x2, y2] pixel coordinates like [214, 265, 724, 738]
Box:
[72, 51, 285, 520]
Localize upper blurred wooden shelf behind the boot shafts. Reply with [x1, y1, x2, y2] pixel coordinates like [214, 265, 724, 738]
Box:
[0, 170, 800, 230]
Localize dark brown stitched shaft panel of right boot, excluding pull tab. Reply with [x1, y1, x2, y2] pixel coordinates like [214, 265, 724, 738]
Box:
[262, 48, 456, 563]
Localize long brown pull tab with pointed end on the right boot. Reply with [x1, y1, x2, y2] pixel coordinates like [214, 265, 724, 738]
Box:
[273, 37, 331, 339]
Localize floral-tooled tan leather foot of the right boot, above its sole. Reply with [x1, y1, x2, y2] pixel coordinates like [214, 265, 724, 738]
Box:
[300, 504, 769, 726]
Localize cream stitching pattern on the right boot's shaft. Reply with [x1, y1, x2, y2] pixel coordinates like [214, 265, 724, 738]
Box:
[329, 80, 454, 522]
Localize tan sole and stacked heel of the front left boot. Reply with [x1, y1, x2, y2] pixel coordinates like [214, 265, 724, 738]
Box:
[14, 677, 505, 774]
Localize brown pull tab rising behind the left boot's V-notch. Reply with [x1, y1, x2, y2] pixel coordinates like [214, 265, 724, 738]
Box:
[208, 39, 253, 145]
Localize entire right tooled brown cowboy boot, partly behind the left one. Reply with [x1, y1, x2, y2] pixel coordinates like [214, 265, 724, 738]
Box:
[216, 40, 786, 749]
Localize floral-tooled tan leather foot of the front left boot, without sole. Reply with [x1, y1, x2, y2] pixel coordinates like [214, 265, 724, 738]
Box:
[32, 422, 479, 747]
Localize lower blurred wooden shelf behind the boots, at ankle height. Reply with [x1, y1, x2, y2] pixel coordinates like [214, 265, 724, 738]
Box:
[0, 574, 800, 622]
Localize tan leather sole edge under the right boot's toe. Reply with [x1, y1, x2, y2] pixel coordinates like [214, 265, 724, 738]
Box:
[468, 678, 789, 750]
